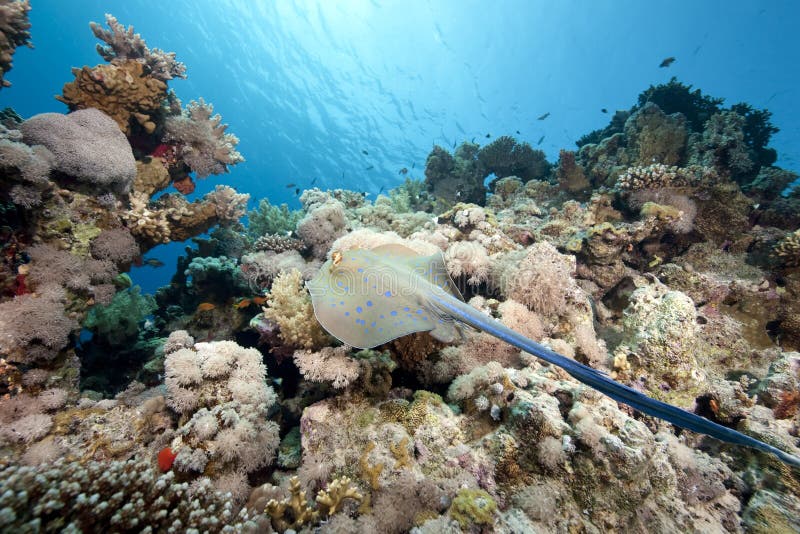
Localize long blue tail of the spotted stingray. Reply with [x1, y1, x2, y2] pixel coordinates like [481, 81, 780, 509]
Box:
[444, 301, 800, 467]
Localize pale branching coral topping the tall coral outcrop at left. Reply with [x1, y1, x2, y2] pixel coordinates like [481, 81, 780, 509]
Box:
[89, 13, 186, 82]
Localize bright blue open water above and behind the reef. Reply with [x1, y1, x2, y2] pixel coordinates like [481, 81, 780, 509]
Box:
[0, 0, 800, 291]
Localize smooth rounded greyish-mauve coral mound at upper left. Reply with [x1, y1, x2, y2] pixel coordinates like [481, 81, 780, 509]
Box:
[20, 109, 136, 193]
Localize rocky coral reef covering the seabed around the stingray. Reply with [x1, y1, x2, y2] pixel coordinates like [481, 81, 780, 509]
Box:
[0, 12, 800, 533]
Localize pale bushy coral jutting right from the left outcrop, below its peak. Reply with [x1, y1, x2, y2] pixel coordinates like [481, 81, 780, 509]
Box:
[164, 98, 244, 178]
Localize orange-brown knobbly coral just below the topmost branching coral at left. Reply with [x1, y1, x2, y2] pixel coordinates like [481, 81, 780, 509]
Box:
[56, 60, 167, 135]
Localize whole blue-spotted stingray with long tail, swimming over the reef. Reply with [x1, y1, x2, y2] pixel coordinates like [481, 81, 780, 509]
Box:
[307, 245, 800, 467]
